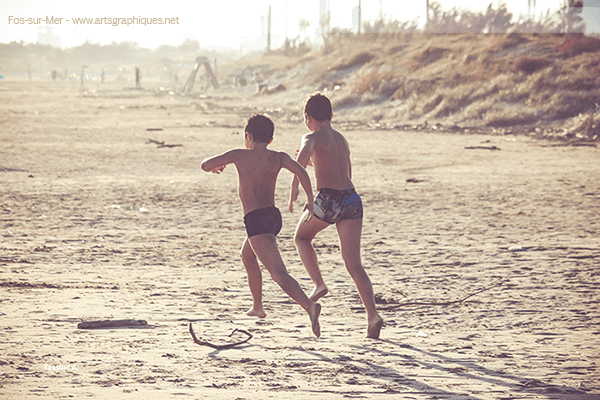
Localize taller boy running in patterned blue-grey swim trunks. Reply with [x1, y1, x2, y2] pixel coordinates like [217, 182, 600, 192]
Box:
[289, 93, 383, 339]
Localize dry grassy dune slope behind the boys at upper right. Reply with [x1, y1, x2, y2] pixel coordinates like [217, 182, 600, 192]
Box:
[246, 33, 600, 140]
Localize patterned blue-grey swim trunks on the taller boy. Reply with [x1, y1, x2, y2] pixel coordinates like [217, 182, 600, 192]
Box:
[315, 189, 363, 224]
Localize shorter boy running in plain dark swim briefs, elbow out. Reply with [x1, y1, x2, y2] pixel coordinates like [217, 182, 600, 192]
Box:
[202, 114, 321, 336]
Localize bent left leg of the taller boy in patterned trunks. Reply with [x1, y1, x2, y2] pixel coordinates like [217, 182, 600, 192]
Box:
[294, 211, 329, 301]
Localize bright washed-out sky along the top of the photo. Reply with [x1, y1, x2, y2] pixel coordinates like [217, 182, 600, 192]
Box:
[0, 0, 600, 49]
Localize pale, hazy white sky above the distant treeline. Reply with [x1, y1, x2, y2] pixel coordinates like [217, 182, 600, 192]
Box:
[0, 0, 600, 54]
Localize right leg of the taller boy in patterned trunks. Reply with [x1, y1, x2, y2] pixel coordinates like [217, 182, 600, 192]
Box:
[336, 219, 383, 339]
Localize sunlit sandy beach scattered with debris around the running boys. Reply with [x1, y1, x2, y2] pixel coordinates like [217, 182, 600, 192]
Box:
[0, 80, 600, 400]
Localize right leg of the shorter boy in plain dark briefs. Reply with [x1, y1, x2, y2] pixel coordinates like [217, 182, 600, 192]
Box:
[249, 234, 321, 337]
